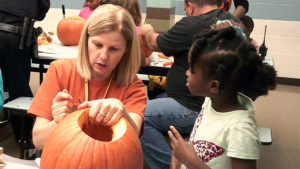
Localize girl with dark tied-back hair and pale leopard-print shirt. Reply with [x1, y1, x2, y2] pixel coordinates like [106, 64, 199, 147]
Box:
[168, 27, 276, 169]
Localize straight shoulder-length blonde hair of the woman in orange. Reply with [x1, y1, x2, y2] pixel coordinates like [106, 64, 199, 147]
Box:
[77, 4, 141, 85]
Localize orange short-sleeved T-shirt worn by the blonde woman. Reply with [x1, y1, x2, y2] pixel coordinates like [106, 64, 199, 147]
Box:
[28, 59, 147, 120]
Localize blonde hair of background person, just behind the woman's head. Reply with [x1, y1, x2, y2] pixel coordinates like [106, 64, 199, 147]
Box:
[99, 0, 142, 26]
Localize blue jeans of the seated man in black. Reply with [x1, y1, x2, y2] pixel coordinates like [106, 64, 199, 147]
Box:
[140, 97, 199, 169]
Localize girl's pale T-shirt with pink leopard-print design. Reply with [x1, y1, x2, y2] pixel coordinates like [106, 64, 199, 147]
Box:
[182, 94, 260, 169]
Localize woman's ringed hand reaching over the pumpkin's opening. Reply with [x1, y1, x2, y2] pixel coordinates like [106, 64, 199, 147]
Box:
[78, 98, 126, 126]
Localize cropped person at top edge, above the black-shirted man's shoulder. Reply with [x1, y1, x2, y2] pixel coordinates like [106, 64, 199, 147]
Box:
[218, 0, 249, 18]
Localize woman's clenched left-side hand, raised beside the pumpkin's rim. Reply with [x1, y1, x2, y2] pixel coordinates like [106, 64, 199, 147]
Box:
[51, 89, 77, 124]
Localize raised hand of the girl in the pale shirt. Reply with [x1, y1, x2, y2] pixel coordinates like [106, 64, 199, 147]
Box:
[168, 126, 197, 164]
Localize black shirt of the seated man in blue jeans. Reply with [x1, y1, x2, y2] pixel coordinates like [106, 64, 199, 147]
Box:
[156, 9, 239, 111]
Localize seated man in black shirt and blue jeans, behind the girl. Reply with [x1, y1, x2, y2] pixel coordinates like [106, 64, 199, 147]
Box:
[140, 0, 244, 169]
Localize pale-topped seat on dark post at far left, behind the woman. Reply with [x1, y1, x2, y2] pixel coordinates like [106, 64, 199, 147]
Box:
[3, 97, 34, 159]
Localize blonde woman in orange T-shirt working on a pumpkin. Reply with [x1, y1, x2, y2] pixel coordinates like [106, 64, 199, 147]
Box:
[28, 5, 147, 149]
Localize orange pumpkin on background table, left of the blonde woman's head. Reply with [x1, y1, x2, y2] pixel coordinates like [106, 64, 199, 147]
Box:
[57, 16, 86, 46]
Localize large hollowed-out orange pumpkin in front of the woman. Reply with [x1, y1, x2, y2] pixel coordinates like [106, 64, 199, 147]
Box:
[41, 109, 143, 169]
